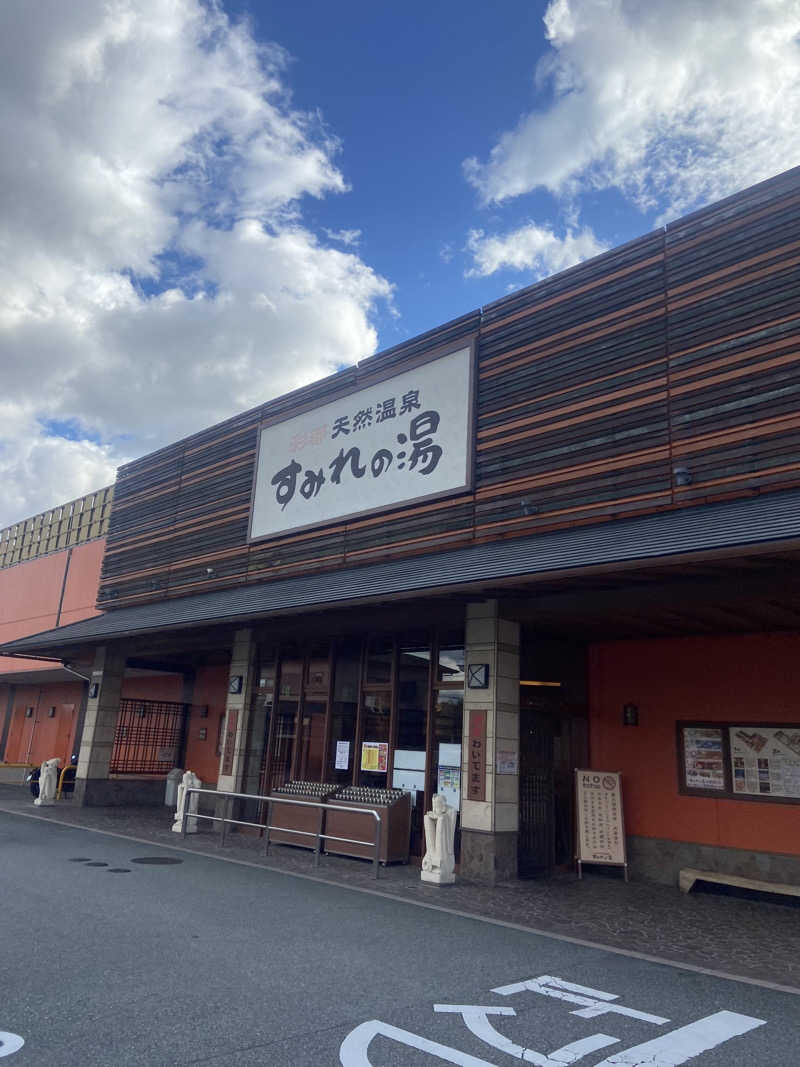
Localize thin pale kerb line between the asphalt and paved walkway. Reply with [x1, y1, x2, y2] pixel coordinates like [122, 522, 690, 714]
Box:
[0, 808, 800, 997]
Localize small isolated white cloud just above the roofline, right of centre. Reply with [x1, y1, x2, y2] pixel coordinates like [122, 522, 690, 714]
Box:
[466, 222, 606, 277]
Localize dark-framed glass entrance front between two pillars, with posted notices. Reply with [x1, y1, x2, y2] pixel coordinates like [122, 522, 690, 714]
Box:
[245, 627, 464, 856]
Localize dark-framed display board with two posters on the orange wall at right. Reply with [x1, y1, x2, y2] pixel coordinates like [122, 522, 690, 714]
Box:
[677, 722, 800, 803]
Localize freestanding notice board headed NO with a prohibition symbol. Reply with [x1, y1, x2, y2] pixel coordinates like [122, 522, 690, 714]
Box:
[575, 770, 628, 880]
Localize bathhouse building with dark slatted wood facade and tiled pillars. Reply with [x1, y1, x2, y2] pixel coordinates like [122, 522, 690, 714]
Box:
[1, 169, 800, 882]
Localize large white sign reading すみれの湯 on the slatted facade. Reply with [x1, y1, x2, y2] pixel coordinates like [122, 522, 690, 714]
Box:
[250, 349, 471, 539]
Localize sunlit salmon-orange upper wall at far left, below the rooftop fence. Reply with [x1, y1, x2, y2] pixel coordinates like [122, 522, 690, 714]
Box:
[0, 538, 106, 676]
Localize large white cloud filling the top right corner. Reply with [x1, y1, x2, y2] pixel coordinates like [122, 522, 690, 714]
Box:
[464, 0, 800, 218]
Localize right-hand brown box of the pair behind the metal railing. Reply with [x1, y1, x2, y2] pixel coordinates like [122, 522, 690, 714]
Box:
[324, 785, 411, 863]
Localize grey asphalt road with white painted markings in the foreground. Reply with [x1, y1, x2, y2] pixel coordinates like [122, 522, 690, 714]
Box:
[0, 813, 800, 1067]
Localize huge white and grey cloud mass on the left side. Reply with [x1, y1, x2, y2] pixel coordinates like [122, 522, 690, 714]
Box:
[0, 0, 391, 526]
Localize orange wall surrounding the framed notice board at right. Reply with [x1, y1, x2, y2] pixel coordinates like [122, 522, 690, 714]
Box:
[589, 634, 800, 855]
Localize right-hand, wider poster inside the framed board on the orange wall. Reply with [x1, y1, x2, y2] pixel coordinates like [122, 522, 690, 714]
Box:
[729, 726, 800, 799]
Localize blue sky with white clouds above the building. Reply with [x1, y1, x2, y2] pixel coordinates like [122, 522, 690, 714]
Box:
[0, 0, 800, 527]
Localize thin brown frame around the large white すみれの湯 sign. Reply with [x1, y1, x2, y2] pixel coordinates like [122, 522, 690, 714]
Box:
[247, 334, 477, 544]
